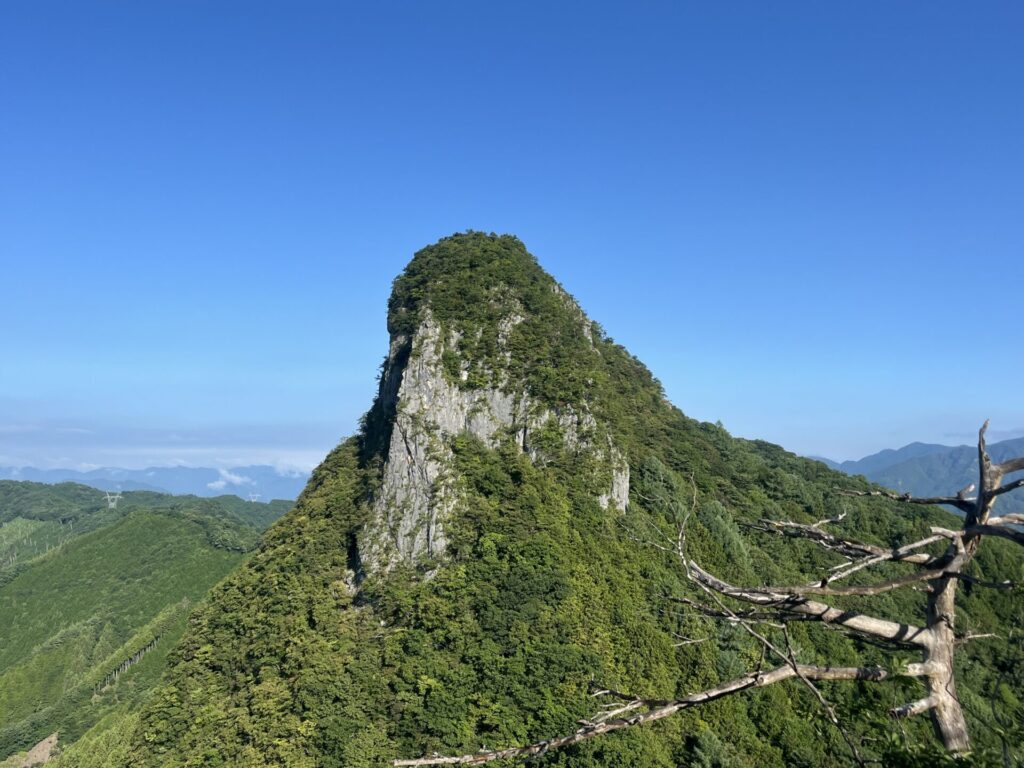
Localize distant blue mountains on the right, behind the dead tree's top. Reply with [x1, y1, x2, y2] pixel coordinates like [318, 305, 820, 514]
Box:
[815, 437, 1024, 512]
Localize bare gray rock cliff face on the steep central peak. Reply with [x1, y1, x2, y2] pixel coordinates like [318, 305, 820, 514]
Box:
[358, 309, 630, 573]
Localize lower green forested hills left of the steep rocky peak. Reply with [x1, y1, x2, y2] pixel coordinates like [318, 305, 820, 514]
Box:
[0, 481, 289, 762]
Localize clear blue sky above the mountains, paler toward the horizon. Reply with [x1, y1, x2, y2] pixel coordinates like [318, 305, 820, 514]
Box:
[0, 0, 1024, 466]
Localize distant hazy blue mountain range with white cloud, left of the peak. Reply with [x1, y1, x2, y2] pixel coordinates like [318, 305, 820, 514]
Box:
[0, 465, 309, 502]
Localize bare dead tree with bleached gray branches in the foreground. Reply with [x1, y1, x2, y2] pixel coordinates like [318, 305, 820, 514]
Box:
[392, 421, 1024, 766]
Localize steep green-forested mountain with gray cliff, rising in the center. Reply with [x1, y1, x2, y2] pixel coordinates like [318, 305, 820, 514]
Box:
[123, 232, 1022, 768]
